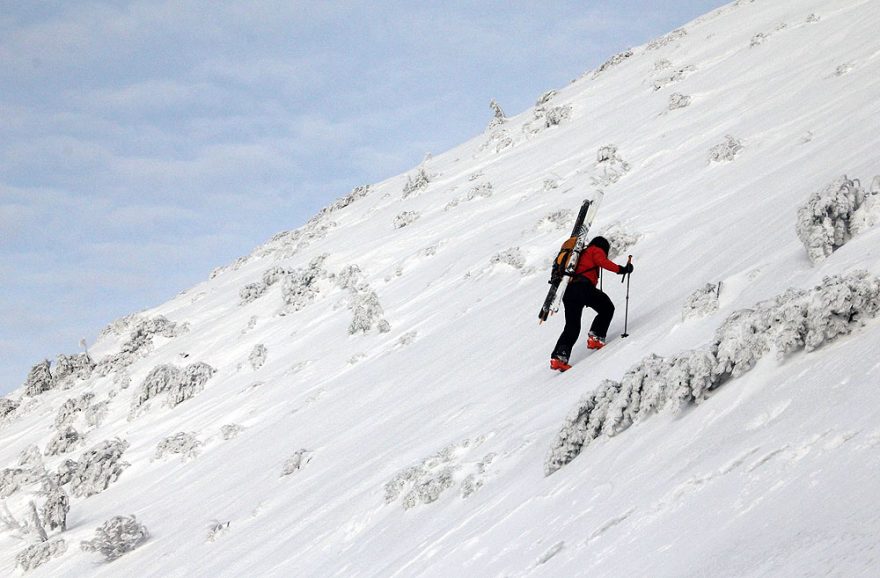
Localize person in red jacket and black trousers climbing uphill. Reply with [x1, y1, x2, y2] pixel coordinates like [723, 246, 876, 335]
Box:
[550, 237, 633, 371]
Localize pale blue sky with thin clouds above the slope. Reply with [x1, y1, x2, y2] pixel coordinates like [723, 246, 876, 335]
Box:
[0, 0, 726, 393]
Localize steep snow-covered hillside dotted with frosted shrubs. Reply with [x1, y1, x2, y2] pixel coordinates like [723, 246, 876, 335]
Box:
[0, 0, 880, 576]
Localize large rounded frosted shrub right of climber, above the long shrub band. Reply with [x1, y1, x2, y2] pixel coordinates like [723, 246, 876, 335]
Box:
[795, 175, 865, 263]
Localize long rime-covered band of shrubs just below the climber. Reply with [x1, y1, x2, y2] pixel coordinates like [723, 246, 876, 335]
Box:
[545, 271, 880, 475]
